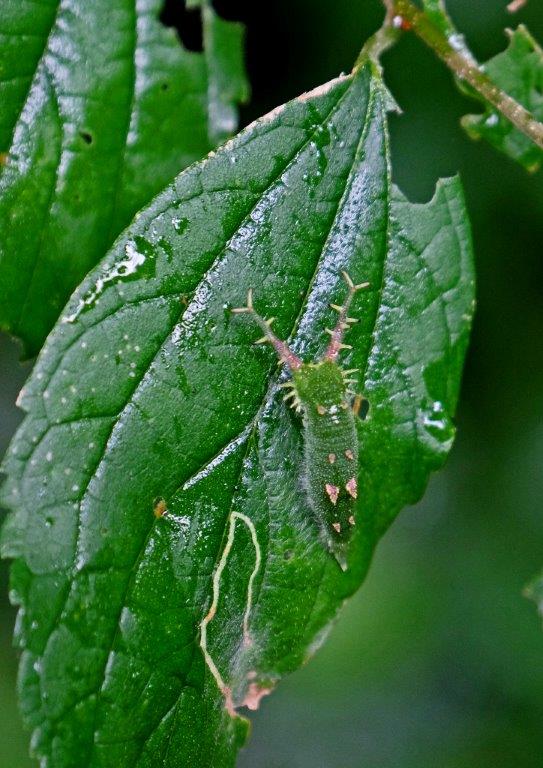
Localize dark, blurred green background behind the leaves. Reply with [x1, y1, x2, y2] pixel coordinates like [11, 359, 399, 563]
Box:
[0, 0, 543, 768]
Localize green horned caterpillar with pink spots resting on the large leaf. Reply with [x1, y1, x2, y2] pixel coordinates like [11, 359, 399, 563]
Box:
[233, 272, 369, 570]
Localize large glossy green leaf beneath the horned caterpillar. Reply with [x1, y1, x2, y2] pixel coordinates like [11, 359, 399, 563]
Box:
[3, 65, 473, 768]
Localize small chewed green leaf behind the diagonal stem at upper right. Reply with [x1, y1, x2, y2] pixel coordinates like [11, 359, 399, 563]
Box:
[462, 26, 543, 171]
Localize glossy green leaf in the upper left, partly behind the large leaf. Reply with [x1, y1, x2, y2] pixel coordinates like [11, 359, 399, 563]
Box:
[0, 0, 248, 355]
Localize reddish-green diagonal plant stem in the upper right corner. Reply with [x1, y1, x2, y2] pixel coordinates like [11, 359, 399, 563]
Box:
[383, 0, 543, 149]
